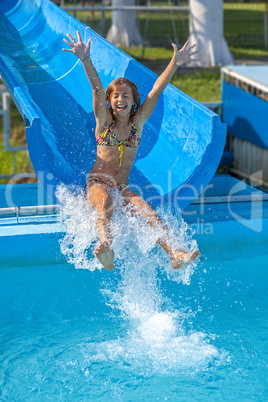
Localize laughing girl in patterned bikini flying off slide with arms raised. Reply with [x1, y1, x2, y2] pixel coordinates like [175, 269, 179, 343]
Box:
[63, 31, 200, 271]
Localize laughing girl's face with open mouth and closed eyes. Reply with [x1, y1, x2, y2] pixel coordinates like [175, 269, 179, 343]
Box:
[110, 84, 135, 116]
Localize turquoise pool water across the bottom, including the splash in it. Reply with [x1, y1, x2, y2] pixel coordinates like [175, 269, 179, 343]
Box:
[0, 253, 267, 401]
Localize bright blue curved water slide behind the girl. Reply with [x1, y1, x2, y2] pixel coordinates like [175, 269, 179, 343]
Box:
[0, 0, 226, 209]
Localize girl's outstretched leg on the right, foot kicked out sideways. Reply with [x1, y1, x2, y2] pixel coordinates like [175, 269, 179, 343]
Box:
[123, 189, 200, 269]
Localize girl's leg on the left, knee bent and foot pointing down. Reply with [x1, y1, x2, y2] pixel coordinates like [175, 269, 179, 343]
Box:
[87, 183, 114, 271]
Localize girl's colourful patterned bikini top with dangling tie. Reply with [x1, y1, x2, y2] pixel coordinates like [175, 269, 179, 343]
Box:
[96, 121, 141, 167]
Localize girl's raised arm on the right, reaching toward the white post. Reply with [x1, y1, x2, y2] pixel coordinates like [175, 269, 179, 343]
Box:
[135, 41, 199, 126]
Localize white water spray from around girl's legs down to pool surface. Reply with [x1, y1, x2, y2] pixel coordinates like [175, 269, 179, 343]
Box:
[57, 186, 225, 373]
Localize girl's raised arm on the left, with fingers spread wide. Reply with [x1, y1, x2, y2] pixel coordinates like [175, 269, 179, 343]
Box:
[62, 31, 111, 129]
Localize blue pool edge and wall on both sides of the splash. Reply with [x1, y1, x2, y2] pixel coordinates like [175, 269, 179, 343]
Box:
[0, 177, 268, 267]
